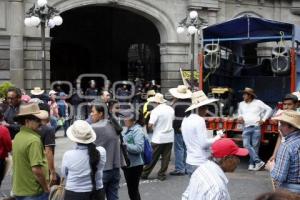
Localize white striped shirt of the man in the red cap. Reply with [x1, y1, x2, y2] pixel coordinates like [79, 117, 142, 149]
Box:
[182, 160, 230, 200]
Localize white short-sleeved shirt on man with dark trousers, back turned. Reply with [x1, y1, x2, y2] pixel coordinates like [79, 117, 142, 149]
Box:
[149, 104, 175, 144]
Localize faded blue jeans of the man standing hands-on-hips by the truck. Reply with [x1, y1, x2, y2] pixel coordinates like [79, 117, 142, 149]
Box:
[242, 126, 261, 165]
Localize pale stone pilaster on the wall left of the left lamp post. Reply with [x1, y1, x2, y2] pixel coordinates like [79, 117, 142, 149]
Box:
[9, 0, 24, 88]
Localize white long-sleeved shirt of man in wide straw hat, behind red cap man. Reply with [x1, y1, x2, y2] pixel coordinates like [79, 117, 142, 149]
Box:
[181, 114, 214, 166]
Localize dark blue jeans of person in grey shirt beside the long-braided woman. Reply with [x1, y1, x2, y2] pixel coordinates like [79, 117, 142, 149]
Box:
[103, 168, 121, 200]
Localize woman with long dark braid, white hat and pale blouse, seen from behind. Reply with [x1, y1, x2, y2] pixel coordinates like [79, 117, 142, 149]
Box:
[62, 120, 106, 200]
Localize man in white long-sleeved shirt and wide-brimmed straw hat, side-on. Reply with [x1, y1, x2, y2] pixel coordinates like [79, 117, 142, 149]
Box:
[181, 91, 220, 175]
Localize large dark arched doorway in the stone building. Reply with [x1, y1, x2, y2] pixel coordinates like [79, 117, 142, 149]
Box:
[50, 6, 160, 85]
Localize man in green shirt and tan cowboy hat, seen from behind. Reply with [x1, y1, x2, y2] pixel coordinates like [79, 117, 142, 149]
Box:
[12, 103, 49, 200]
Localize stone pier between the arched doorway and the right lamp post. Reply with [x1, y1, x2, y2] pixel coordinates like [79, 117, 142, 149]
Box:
[160, 43, 188, 93]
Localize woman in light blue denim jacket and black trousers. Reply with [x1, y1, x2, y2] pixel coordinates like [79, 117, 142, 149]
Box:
[122, 112, 145, 200]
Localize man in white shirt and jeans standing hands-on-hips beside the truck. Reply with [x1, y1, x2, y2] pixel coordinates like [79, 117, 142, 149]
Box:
[238, 88, 272, 171]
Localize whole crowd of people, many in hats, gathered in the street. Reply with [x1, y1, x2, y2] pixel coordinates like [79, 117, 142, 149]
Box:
[0, 81, 300, 200]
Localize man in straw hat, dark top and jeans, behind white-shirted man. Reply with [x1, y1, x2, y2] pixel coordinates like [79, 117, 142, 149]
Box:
[169, 85, 192, 176]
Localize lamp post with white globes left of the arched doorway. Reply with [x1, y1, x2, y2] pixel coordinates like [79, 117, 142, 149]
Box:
[24, 0, 63, 89]
